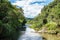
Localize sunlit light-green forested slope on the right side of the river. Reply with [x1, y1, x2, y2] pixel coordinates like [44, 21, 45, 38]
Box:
[27, 0, 60, 33]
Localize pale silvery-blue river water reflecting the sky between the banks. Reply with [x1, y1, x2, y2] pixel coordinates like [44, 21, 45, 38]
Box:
[18, 25, 42, 40]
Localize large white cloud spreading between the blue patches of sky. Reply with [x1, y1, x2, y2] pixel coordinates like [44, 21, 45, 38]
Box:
[12, 0, 52, 18]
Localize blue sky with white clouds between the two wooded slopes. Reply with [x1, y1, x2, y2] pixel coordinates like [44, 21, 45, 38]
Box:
[10, 0, 53, 18]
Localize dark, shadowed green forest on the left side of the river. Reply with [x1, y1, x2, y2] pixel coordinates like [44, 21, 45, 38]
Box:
[0, 0, 26, 40]
